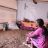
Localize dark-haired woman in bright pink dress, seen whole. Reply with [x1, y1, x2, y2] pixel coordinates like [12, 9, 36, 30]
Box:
[26, 19, 46, 48]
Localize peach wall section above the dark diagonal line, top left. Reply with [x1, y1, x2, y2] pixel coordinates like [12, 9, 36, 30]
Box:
[0, 0, 17, 9]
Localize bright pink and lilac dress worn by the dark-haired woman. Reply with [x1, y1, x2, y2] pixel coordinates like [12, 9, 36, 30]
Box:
[26, 27, 45, 48]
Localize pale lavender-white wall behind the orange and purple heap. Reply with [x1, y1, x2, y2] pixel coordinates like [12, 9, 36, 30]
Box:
[17, 0, 48, 20]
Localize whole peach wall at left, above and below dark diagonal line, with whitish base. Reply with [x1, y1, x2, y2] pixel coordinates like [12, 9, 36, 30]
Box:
[0, 0, 17, 29]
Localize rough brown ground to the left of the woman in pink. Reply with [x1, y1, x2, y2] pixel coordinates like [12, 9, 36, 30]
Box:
[0, 30, 32, 48]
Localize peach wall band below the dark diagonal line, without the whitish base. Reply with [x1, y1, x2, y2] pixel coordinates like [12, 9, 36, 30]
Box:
[0, 7, 16, 23]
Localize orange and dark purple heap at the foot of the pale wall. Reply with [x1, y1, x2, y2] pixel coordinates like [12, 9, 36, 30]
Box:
[16, 19, 36, 30]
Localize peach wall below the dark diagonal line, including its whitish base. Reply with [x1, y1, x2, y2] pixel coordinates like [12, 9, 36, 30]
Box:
[0, 7, 16, 29]
